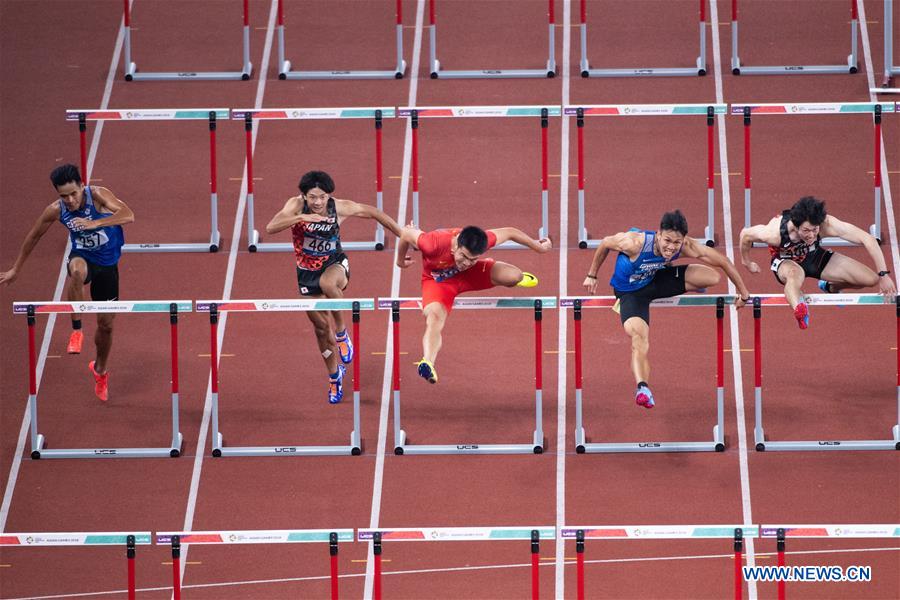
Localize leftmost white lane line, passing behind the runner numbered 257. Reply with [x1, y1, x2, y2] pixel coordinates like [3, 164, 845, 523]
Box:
[0, 3, 125, 531]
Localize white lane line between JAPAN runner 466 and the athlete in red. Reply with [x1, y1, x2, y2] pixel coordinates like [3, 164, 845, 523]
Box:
[363, 0, 425, 600]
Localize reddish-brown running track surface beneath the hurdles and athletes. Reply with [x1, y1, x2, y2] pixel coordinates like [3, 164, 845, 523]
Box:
[0, 0, 900, 598]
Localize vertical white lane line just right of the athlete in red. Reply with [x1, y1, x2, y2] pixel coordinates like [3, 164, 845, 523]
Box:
[555, 0, 572, 600]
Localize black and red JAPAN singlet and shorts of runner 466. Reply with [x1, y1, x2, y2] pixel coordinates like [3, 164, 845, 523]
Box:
[291, 198, 350, 296]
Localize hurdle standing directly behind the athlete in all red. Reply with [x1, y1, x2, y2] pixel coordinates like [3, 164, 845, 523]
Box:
[397, 106, 560, 249]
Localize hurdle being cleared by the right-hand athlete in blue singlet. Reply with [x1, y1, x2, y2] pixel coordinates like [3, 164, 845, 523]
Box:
[559, 295, 735, 454]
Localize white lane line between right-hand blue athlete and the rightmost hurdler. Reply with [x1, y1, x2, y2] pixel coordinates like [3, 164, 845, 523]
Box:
[709, 2, 757, 600]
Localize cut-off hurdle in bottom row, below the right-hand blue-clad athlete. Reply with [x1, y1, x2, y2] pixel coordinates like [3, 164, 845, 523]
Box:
[559, 525, 759, 600]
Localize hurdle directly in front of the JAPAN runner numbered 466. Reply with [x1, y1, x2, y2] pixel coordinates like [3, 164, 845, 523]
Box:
[196, 298, 375, 458]
